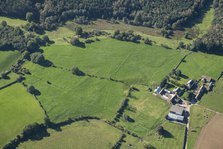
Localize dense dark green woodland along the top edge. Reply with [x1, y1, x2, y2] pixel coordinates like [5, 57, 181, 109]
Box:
[0, 0, 210, 29]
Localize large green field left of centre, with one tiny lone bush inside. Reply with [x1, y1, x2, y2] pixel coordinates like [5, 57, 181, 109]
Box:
[25, 63, 127, 122]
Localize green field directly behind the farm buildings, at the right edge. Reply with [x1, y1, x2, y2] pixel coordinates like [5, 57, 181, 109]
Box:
[179, 52, 223, 80]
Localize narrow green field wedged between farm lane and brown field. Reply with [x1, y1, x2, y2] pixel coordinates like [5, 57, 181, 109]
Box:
[187, 105, 215, 149]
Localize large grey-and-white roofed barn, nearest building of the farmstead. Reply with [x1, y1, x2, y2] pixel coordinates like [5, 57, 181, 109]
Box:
[167, 105, 185, 122]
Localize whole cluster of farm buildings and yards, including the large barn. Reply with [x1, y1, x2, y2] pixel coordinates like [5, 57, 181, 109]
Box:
[154, 76, 215, 123]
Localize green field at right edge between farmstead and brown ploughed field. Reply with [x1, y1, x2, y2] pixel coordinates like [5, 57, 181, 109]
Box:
[200, 78, 223, 113]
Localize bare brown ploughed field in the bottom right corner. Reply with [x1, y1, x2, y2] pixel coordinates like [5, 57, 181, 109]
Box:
[195, 114, 223, 149]
